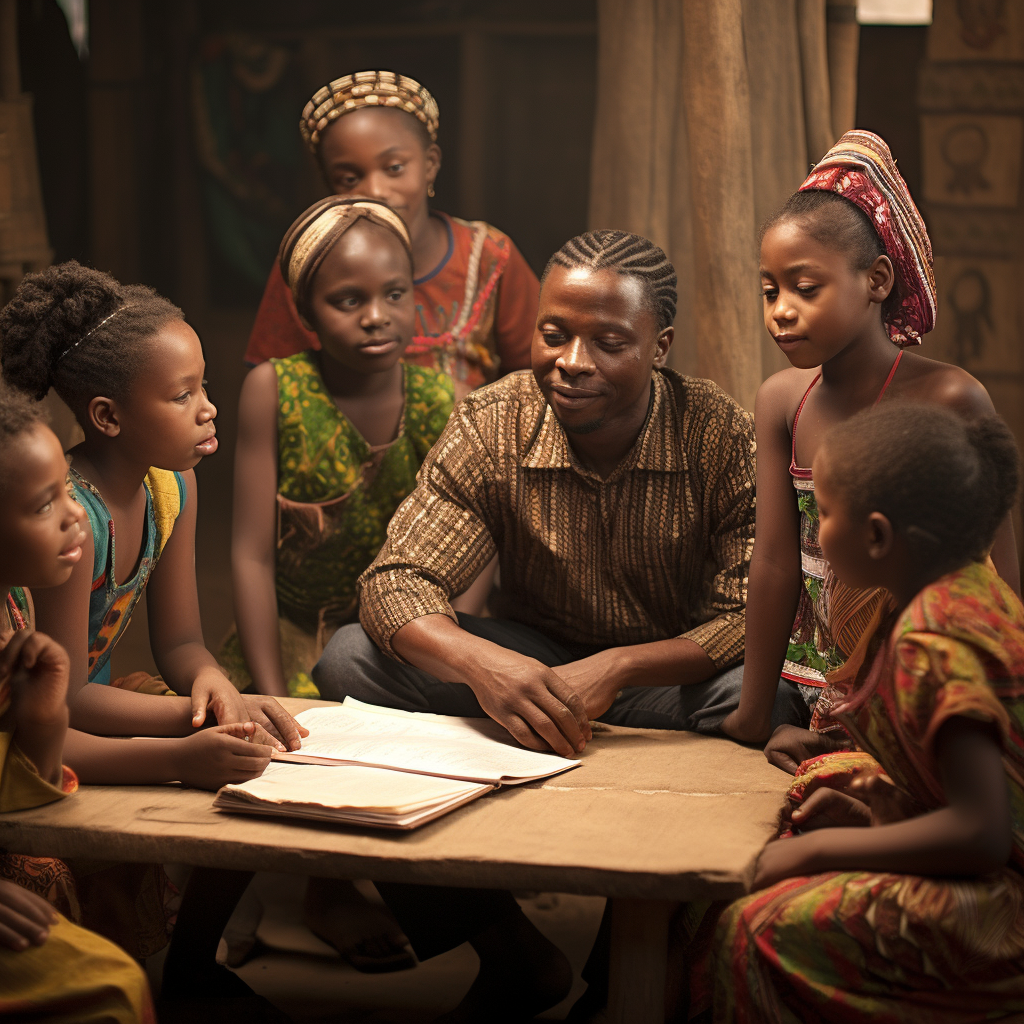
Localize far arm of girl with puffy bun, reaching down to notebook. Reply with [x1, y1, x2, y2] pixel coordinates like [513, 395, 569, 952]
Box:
[146, 470, 307, 751]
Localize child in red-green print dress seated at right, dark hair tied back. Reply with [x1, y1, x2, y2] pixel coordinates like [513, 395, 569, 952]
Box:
[697, 402, 1024, 1024]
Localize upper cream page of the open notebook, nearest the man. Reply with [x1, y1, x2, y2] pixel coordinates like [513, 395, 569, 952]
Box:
[274, 701, 580, 785]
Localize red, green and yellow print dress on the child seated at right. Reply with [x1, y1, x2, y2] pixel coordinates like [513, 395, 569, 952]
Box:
[713, 563, 1024, 1024]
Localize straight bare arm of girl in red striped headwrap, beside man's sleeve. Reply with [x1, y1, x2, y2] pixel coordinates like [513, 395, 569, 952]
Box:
[722, 371, 801, 742]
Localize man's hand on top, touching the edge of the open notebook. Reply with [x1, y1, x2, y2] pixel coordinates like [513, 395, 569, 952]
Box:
[469, 651, 592, 758]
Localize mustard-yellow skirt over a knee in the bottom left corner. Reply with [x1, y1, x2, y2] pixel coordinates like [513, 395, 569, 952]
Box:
[0, 918, 156, 1024]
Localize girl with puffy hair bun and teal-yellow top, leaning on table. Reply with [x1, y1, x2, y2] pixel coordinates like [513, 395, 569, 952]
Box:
[0, 262, 304, 999]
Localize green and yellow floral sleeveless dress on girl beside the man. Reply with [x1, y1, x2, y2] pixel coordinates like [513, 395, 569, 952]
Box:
[219, 351, 454, 696]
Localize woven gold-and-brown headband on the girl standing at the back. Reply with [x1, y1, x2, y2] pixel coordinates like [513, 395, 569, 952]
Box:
[299, 71, 439, 156]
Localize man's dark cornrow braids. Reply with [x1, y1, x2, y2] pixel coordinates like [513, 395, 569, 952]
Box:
[541, 228, 677, 331]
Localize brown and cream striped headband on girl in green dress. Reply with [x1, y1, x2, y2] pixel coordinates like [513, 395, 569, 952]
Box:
[278, 196, 413, 321]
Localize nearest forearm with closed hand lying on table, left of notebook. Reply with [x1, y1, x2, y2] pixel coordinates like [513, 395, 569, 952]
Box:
[65, 720, 272, 790]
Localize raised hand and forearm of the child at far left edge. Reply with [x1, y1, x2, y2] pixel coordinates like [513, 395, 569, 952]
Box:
[0, 630, 69, 785]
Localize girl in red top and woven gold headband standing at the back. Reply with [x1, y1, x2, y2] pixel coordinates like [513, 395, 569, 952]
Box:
[246, 71, 540, 397]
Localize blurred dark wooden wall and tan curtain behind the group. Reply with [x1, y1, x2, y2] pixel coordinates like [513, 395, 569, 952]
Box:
[0, 0, 1024, 668]
